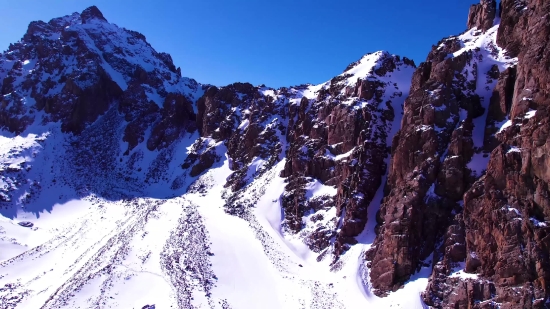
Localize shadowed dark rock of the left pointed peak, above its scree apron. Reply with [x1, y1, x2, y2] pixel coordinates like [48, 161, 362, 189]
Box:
[0, 7, 202, 140]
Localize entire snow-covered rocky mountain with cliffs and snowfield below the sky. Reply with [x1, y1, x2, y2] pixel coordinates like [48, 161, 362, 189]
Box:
[0, 0, 550, 309]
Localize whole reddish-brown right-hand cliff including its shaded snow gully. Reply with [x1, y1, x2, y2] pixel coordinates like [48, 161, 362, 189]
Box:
[366, 1, 550, 308]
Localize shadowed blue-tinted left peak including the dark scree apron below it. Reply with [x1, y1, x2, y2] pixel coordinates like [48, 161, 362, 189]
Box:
[0, 7, 204, 202]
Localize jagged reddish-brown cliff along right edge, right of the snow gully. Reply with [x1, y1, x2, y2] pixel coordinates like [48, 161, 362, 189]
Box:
[424, 0, 550, 308]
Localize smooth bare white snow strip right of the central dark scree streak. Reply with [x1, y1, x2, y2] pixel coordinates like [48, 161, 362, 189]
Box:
[190, 180, 283, 308]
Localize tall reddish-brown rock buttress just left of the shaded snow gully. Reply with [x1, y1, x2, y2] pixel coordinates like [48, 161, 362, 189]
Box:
[366, 35, 483, 295]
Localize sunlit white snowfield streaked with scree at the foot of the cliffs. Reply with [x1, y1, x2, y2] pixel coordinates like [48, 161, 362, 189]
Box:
[0, 146, 429, 308]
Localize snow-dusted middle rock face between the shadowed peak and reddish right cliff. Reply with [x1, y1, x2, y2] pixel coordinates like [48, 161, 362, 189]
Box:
[190, 52, 415, 261]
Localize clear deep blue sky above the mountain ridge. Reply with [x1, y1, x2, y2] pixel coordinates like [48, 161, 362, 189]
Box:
[0, 0, 479, 87]
